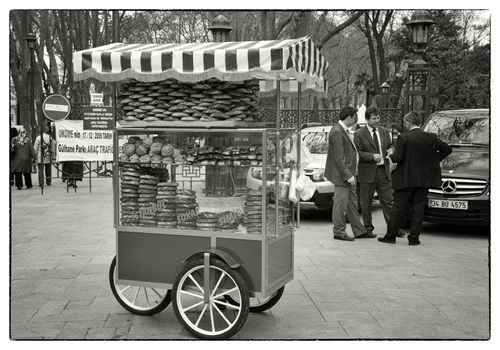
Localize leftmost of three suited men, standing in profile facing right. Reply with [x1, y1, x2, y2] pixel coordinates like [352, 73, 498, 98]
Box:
[325, 107, 369, 241]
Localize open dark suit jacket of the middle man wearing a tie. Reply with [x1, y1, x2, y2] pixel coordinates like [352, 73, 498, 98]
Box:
[354, 126, 392, 183]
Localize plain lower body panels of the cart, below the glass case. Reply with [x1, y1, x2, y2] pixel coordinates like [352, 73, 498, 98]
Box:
[117, 226, 293, 297]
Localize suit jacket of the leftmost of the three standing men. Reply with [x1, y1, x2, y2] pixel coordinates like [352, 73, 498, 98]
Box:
[325, 122, 358, 186]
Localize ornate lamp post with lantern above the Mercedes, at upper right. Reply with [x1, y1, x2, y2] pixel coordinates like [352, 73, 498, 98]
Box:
[404, 10, 434, 122]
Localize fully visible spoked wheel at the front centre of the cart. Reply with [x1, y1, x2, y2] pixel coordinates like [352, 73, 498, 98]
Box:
[173, 258, 249, 339]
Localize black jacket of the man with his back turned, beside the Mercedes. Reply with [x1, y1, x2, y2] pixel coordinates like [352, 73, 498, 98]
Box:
[391, 128, 451, 190]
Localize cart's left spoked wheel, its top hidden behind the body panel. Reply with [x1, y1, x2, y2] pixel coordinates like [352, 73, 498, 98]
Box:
[109, 256, 171, 316]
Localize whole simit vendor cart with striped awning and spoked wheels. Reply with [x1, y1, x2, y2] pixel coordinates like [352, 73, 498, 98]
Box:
[73, 37, 328, 339]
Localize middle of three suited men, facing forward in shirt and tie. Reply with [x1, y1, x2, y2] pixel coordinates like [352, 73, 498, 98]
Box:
[354, 107, 392, 237]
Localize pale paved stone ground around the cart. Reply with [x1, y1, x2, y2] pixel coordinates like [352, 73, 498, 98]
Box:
[10, 179, 490, 339]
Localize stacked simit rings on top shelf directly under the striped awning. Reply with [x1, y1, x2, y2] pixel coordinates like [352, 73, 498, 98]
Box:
[119, 78, 260, 122]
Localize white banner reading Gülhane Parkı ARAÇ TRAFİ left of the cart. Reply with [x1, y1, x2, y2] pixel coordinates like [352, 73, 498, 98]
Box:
[55, 120, 113, 162]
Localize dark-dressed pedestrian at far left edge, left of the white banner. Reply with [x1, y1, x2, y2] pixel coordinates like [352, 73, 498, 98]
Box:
[10, 130, 36, 189]
